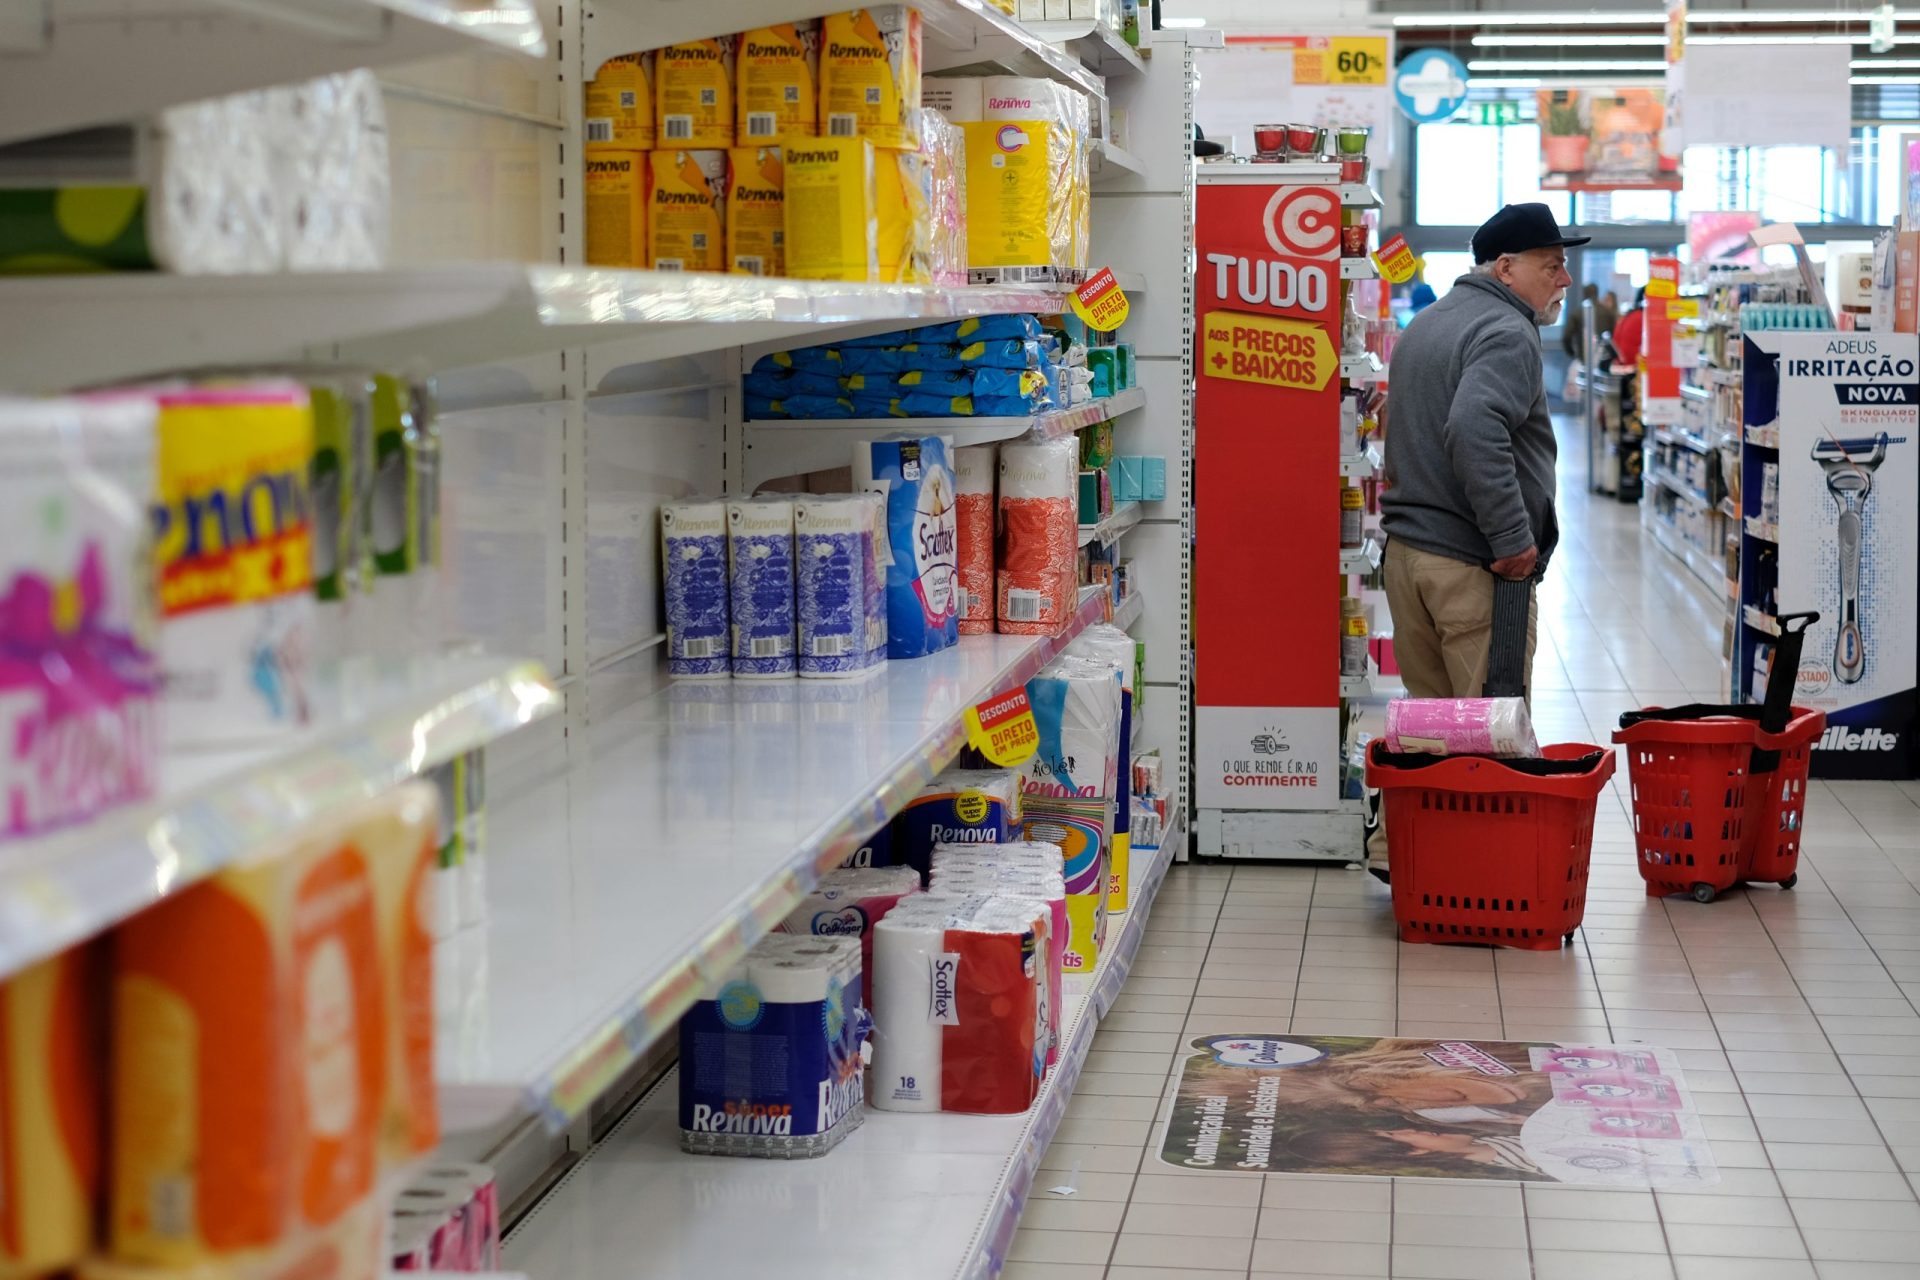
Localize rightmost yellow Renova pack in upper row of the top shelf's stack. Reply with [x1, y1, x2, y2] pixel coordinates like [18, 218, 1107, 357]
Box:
[820, 4, 920, 150]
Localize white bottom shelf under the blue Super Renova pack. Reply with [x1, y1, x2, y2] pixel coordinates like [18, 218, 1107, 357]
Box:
[507, 808, 1185, 1280]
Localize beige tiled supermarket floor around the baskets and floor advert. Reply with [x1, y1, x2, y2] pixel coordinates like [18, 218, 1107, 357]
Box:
[1029, 433, 1920, 1280]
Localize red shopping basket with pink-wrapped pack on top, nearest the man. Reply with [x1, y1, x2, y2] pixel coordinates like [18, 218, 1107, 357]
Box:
[1367, 741, 1613, 952]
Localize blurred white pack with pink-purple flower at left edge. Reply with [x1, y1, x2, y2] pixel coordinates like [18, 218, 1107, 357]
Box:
[0, 397, 159, 844]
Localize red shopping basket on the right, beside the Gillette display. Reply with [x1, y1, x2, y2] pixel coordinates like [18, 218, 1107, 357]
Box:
[1613, 706, 1826, 902]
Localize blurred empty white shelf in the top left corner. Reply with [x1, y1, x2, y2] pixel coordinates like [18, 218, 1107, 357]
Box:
[0, 0, 547, 146]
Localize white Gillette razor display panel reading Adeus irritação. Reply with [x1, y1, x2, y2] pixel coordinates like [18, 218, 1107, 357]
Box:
[1738, 330, 1920, 779]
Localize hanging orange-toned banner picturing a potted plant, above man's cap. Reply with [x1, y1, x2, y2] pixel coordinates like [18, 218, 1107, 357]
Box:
[1538, 88, 1680, 192]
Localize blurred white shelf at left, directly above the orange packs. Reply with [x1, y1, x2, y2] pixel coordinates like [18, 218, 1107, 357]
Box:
[0, 656, 559, 979]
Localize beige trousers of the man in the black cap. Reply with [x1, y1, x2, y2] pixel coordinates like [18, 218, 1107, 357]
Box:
[1367, 539, 1540, 867]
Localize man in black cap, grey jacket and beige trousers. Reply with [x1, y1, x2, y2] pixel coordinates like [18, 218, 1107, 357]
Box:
[1371, 203, 1586, 881]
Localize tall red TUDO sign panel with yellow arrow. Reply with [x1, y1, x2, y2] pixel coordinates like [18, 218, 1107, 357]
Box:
[1192, 165, 1340, 810]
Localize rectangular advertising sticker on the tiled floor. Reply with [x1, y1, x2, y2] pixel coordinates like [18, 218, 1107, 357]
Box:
[1160, 1034, 1720, 1190]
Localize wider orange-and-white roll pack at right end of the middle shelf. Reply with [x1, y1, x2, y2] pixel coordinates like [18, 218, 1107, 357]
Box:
[995, 439, 1079, 635]
